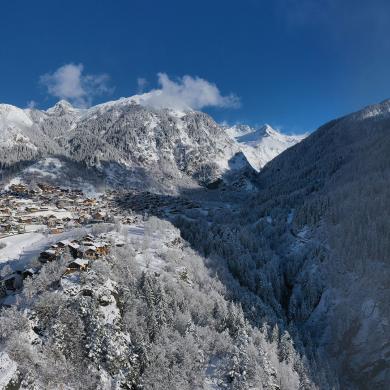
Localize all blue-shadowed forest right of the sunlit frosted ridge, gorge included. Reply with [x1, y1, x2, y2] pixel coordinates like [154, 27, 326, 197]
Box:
[174, 101, 390, 389]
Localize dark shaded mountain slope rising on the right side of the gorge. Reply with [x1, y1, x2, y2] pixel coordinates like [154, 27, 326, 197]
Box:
[251, 96, 390, 389]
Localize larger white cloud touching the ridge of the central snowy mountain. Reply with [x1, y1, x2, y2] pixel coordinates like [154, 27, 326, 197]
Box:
[138, 73, 240, 110]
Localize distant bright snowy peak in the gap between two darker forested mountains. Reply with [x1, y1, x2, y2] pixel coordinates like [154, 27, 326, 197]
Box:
[225, 124, 306, 171]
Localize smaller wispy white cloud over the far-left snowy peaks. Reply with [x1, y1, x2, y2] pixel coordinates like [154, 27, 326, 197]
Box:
[40, 64, 113, 107]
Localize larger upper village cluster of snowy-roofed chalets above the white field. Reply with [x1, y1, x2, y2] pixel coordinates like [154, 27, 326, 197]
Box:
[0, 184, 134, 238]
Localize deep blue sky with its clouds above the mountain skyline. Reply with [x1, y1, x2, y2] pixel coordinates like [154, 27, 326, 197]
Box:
[0, 0, 390, 132]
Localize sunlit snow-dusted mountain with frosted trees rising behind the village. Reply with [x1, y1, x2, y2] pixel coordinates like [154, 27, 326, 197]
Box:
[0, 99, 250, 189]
